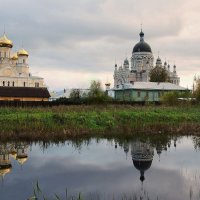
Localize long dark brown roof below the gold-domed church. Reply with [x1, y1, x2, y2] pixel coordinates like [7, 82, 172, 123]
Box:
[0, 86, 50, 98]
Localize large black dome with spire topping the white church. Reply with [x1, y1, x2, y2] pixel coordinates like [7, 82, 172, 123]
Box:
[133, 30, 152, 53]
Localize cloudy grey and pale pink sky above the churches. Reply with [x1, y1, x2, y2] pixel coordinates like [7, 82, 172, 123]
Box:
[0, 0, 200, 90]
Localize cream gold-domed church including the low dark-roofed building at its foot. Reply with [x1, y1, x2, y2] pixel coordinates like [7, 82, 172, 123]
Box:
[0, 34, 50, 101]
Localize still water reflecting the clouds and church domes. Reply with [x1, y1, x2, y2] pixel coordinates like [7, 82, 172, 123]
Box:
[0, 137, 200, 200]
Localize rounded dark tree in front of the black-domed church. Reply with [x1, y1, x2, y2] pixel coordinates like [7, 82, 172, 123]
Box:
[149, 66, 169, 82]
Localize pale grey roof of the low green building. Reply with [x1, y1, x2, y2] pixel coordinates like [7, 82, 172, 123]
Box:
[113, 82, 189, 91]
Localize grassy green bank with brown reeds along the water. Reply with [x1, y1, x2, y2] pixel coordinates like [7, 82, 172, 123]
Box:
[0, 105, 200, 141]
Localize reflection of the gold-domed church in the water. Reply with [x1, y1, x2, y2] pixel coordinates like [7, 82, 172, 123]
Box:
[0, 142, 29, 178]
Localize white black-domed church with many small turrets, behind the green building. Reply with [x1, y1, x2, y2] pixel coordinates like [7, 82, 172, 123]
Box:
[114, 31, 180, 88]
